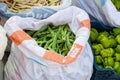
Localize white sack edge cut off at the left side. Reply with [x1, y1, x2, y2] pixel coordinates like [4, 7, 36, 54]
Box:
[0, 25, 7, 60]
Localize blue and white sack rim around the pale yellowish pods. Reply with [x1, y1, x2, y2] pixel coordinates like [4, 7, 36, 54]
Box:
[0, 0, 72, 19]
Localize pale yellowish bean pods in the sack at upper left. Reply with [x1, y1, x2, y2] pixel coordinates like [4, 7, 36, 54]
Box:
[0, 0, 61, 13]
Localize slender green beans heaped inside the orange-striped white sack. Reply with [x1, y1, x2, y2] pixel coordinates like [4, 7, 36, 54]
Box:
[26, 24, 75, 56]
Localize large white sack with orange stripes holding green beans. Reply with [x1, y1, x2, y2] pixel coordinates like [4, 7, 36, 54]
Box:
[5, 6, 93, 80]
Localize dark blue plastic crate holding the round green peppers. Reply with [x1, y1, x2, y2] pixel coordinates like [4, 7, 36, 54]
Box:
[89, 21, 120, 80]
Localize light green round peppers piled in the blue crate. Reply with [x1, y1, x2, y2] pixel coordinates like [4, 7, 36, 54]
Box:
[90, 28, 120, 74]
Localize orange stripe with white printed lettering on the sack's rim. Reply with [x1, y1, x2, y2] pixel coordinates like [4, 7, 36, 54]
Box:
[64, 43, 83, 64]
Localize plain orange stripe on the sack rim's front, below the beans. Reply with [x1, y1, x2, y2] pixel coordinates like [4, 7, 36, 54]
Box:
[43, 50, 64, 64]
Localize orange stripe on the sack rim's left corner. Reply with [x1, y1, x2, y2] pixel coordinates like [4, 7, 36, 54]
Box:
[10, 30, 32, 46]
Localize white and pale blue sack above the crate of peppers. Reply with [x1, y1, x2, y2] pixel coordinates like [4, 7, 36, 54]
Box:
[73, 0, 120, 27]
